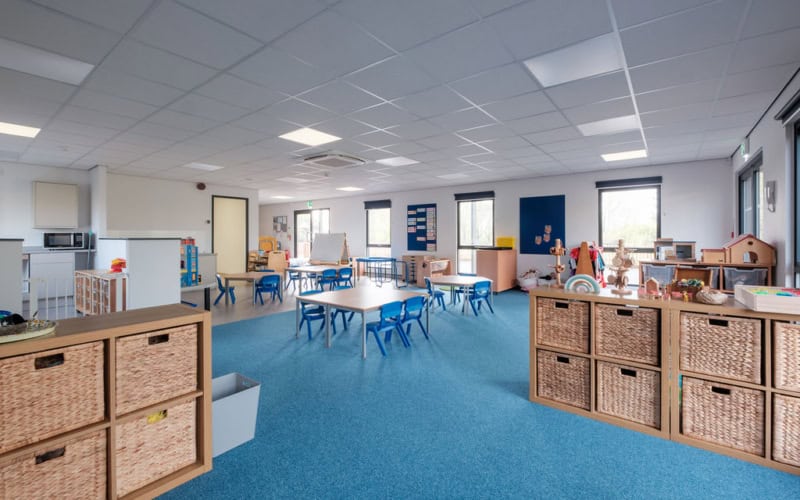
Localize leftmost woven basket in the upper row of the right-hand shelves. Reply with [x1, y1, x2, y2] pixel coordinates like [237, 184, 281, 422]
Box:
[536, 297, 589, 353]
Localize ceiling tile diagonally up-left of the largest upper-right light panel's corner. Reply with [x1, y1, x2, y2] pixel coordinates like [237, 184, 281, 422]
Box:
[405, 23, 514, 82]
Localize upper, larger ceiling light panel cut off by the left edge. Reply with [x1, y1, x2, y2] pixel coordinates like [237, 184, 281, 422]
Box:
[0, 38, 94, 85]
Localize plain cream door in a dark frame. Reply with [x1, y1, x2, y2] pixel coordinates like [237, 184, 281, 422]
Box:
[211, 196, 249, 273]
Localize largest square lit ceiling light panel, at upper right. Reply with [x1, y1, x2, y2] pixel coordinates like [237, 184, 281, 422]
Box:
[525, 33, 622, 87]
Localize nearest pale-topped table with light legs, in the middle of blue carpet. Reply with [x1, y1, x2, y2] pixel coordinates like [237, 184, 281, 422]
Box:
[295, 287, 430, 359]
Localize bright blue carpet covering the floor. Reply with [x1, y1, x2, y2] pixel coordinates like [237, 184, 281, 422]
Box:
[163, 291, 800, 499]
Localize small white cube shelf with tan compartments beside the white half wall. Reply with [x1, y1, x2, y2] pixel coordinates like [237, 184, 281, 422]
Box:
[75, 270, 128, 316]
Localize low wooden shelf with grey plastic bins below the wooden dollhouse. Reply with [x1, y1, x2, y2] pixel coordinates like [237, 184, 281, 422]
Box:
[639, 260, 772, 293]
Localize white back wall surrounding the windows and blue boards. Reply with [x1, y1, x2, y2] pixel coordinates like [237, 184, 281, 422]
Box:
[260, 160, 734, 272]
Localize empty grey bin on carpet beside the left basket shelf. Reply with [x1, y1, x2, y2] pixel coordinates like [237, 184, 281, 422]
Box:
[211, 373, 260, 457]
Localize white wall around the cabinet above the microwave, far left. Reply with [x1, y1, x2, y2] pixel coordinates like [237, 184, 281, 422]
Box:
[0, 162, 90, 247]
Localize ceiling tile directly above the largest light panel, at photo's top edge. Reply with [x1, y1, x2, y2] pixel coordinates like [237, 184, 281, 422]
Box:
[486, 0, 612, 59]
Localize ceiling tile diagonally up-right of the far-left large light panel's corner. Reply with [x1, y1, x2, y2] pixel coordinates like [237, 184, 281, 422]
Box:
[100, 40, 216, 90]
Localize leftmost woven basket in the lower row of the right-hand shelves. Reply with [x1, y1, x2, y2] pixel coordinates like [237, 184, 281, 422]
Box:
[536, 350, 590, 410]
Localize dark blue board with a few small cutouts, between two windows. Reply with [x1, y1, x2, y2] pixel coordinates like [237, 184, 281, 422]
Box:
[519, 194, 567, 255]
